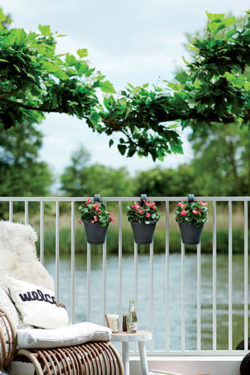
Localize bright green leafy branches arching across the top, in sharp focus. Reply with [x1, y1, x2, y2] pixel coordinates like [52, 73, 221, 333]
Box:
[0, 11, 250, 160]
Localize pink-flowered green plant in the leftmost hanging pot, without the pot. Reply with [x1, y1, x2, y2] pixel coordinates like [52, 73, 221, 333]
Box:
[79, 198, 115, 227]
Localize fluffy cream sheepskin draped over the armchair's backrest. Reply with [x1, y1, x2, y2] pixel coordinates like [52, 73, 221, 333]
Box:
[0, 221, 54, 290]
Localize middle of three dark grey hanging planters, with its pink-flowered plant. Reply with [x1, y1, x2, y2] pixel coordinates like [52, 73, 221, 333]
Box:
[127, 194, 161, 245]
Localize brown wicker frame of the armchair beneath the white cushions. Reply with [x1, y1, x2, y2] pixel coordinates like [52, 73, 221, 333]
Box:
[0, 222, 124, 375]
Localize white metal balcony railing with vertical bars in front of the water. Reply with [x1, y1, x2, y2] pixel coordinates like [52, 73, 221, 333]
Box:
[0, 197, 250, 355]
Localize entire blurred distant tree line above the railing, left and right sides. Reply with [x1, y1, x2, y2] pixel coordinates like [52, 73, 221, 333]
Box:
[0, 124, 250, 203]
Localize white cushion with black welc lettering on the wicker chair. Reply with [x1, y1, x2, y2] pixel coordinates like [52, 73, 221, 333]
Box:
[7, 276, 69, 328]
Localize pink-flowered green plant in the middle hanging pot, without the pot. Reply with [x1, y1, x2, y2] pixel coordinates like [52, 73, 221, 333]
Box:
[127, 200, 161, 224]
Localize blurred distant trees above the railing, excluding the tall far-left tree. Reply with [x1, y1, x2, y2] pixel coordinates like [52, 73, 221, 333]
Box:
[60, 125, 250, 196]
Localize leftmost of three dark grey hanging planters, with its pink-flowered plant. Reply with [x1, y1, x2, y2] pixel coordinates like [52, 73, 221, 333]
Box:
[79, 194, 115, 245]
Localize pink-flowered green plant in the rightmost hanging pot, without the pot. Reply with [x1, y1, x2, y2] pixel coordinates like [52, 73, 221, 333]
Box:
[175, 201, 208, 227]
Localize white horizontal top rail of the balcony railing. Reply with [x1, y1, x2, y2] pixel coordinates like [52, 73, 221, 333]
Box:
[0, 196, 250, 202]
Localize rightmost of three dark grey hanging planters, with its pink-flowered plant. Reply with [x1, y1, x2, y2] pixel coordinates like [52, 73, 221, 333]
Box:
[176, 194, 208, 245]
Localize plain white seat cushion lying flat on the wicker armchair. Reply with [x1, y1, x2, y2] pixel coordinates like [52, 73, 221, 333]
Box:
[17, 322, 112, 349]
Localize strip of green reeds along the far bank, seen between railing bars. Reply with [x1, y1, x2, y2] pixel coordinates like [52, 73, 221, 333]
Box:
[37, 226, 250, 254]
